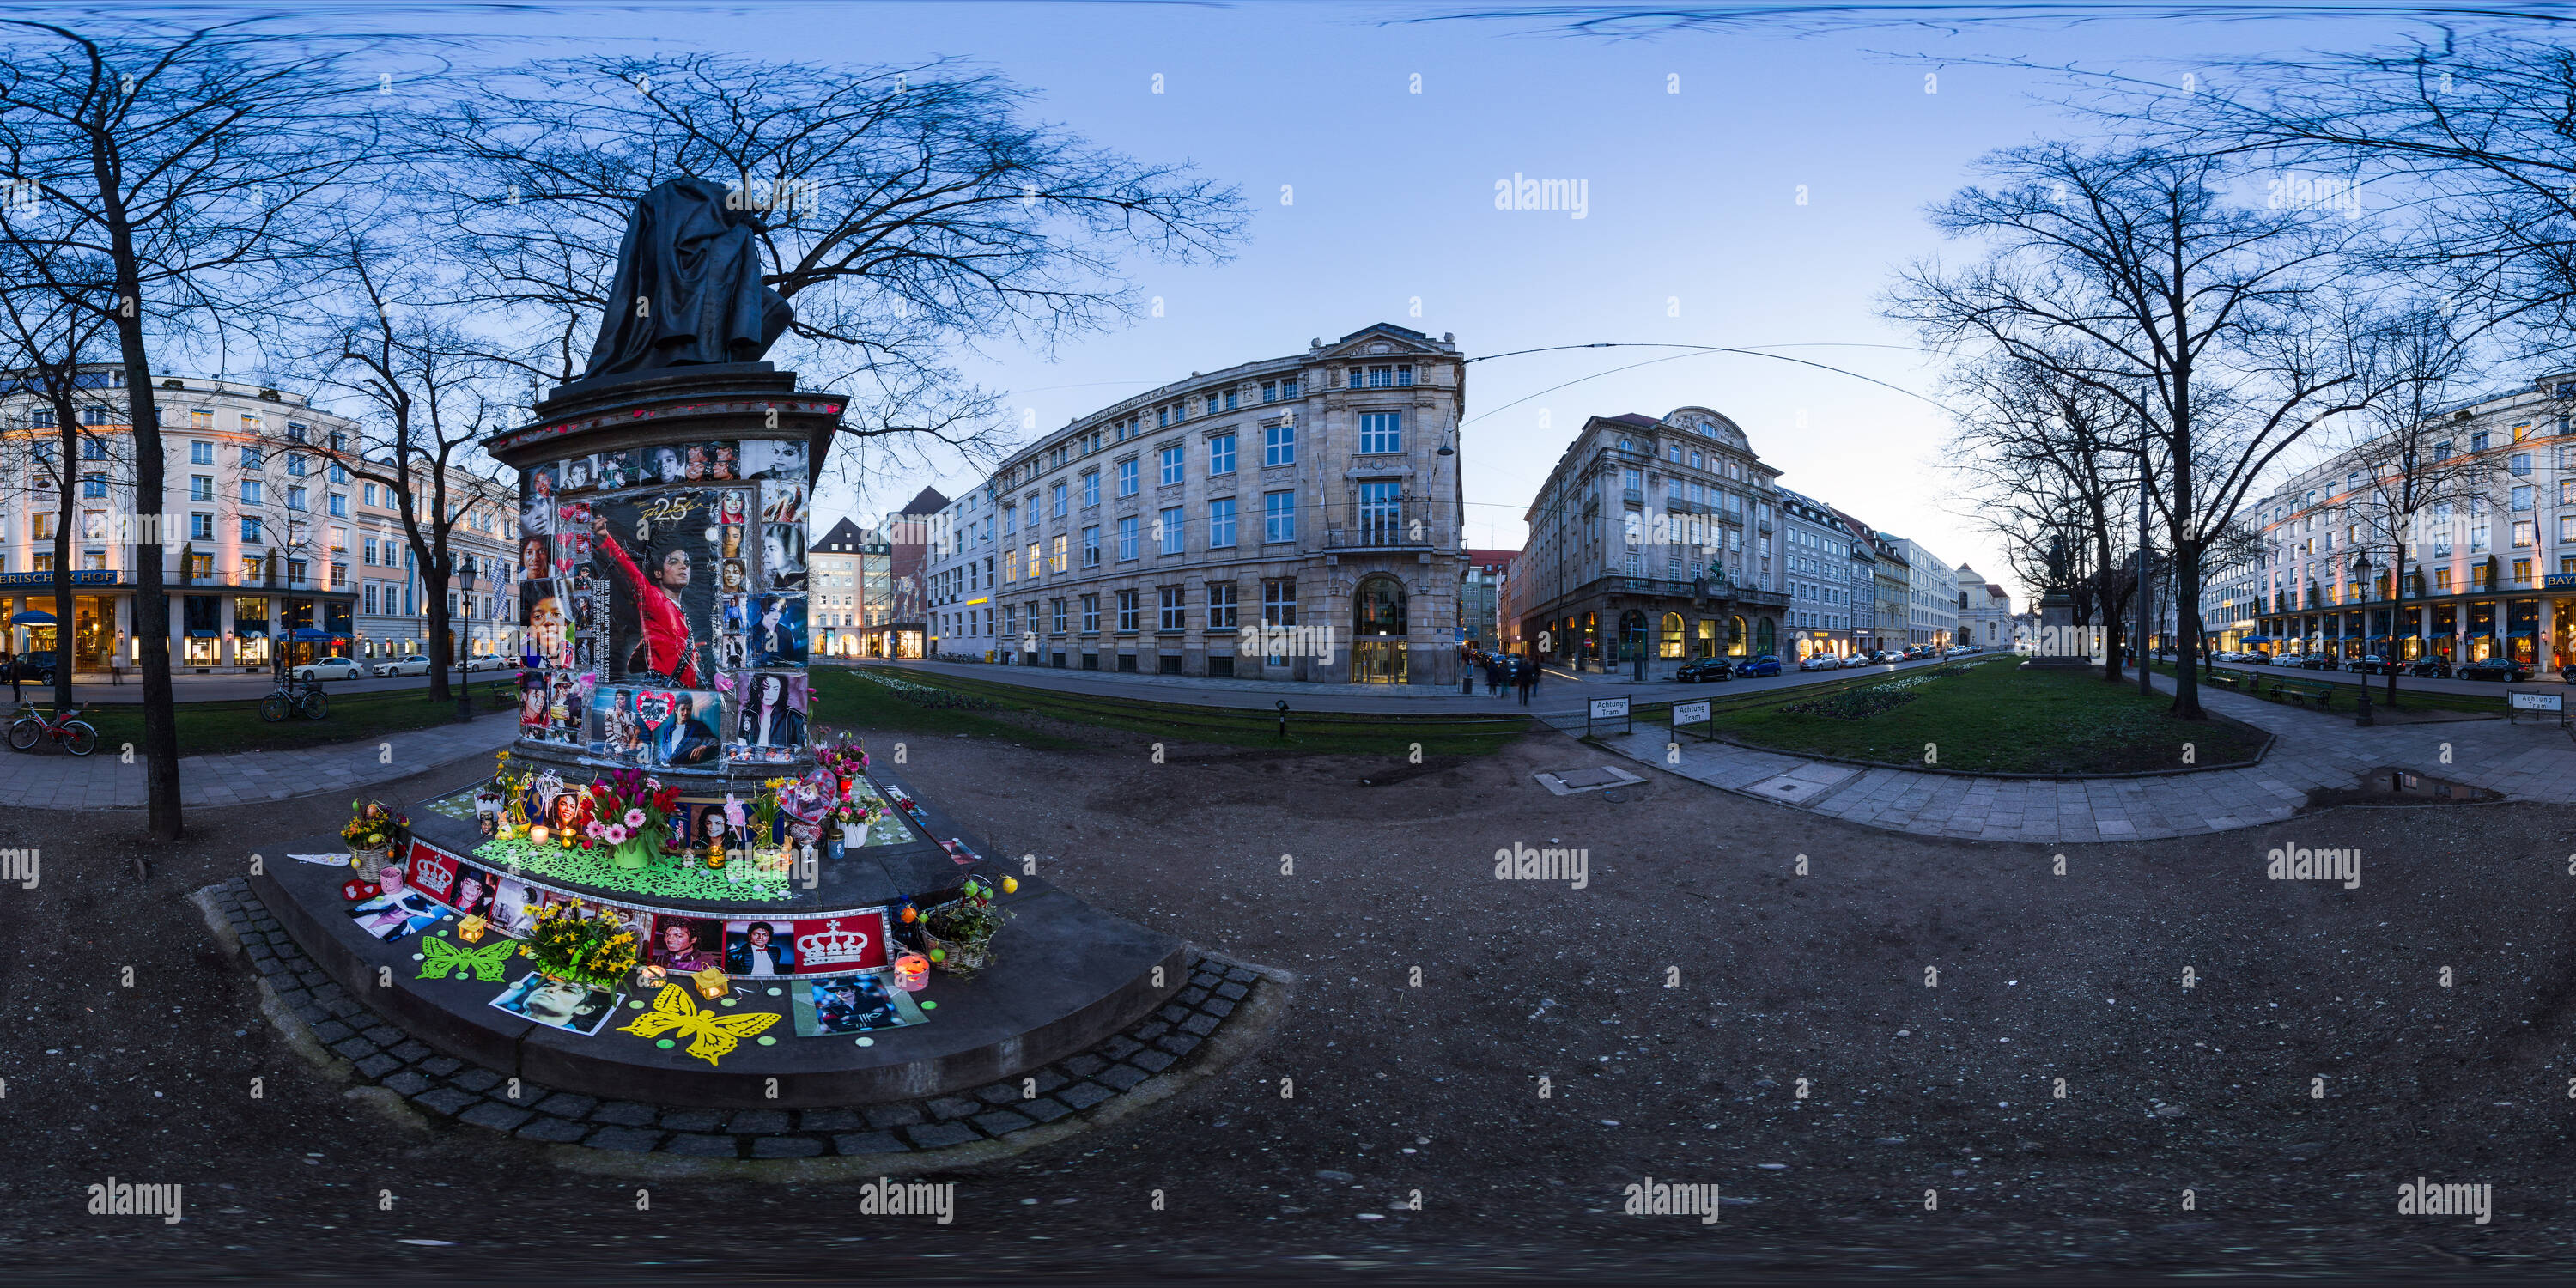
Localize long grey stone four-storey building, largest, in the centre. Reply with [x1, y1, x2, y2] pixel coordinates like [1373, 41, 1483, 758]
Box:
[930, 322, 1466, 685]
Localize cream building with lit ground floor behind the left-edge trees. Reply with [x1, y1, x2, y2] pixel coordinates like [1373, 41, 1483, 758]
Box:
[0, 366, 520, 672]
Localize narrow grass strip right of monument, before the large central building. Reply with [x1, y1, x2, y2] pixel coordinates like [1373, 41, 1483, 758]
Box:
[814, 667, 1528, 755]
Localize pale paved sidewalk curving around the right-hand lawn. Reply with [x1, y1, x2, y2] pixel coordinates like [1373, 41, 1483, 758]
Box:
[1602, 675, 2576, 845]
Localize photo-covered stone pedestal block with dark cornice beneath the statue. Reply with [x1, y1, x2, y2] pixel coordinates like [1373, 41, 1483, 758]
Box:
[484, 363, 842, 799]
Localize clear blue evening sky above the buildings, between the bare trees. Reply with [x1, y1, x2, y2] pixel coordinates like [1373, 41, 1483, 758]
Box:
[166, 3, 2494, 600]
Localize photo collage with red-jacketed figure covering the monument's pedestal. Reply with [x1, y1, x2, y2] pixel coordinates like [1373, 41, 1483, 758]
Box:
[520, 440, 811, 770]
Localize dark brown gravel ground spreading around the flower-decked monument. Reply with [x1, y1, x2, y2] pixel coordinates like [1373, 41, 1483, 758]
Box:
[0, 732, 2576, 1280]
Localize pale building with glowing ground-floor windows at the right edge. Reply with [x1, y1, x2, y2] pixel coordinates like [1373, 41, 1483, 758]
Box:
[2257, 374, 2576, 670]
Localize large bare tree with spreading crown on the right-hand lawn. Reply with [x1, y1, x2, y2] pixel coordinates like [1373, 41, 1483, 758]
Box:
[1888, 144, 2367, 719]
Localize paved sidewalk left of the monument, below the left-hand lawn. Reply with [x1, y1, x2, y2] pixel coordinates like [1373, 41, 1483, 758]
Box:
[0, 711, 518, 811]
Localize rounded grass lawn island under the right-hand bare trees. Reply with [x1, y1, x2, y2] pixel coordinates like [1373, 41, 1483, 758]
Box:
[1716, 657, 2262, 773]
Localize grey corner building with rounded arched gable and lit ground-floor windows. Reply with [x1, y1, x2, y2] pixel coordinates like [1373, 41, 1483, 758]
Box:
[1507, 407, 1790, 675]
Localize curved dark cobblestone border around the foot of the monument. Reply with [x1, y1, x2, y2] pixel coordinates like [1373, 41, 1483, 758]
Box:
[196, 878, 1280, 1162]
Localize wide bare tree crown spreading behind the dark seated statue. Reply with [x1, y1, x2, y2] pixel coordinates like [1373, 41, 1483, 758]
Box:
[425, 54, 1247, 469]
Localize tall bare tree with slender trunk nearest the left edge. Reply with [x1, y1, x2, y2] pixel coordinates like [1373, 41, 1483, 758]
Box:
[0, 18, 376, 842]
